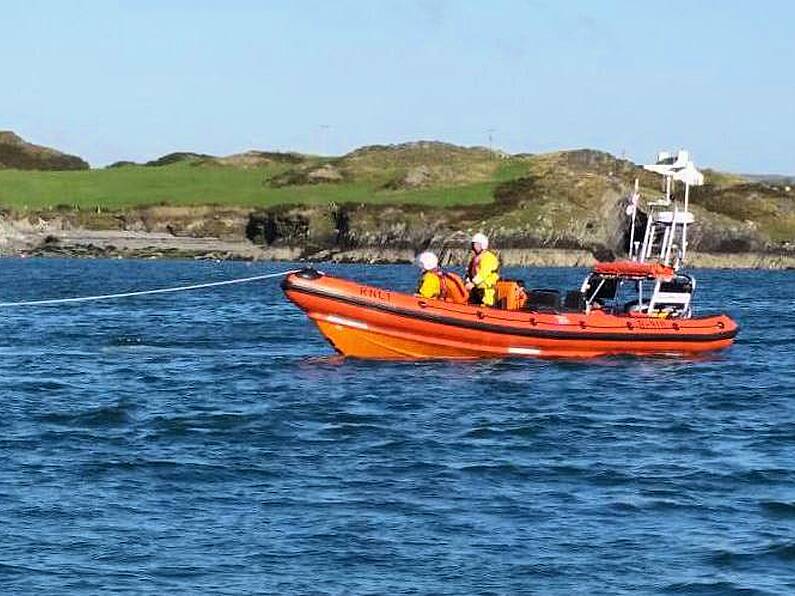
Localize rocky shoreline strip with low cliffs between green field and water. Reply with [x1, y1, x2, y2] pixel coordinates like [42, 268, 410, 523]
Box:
[0, 206, 795, 269]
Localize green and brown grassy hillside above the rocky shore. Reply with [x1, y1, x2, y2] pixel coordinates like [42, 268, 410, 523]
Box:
[0, 136, 795, 251]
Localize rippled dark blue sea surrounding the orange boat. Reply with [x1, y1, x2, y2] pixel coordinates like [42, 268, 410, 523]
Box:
[0, 259, 795, 595]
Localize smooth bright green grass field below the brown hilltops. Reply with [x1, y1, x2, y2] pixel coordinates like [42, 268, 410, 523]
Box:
[0, 161, 526, 210]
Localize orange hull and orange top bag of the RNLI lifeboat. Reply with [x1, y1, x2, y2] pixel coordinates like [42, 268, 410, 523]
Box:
[282, 266, 738, 360]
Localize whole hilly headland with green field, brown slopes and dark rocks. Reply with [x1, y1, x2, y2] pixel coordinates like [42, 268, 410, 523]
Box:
[0, 133, 795, 258]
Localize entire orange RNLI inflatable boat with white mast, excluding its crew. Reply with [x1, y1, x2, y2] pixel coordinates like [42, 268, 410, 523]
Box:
[282, 152, 738, 359]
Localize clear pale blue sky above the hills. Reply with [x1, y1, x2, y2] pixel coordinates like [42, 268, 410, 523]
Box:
[0, 0, 795, 174]
